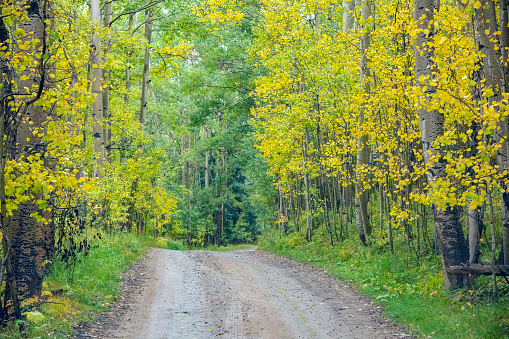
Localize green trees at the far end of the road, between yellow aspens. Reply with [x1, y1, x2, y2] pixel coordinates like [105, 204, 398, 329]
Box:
[158, 12, 265, 247]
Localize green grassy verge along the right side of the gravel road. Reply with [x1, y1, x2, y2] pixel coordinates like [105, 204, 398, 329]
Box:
[259, 233, 509, 339]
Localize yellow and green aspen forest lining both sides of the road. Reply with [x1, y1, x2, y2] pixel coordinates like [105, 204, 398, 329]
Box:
[0, 0, 509, 336]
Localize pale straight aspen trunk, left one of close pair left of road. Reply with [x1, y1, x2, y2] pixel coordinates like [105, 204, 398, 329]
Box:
[90, 0, 104, 178]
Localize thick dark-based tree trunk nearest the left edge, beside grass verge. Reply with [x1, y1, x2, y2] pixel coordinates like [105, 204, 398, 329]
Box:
[0, 0, 54, 318]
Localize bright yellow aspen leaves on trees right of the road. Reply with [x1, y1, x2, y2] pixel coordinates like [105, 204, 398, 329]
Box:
[196, 0, 509, 222]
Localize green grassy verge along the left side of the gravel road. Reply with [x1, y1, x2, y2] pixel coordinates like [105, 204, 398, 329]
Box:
[0, 234, 163, 338]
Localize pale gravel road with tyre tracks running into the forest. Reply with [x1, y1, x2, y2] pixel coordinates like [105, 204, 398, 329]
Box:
[75, 248, 412, 339]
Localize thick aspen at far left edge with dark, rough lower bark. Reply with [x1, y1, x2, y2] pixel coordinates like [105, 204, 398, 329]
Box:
[0, 0, 54, 319]
